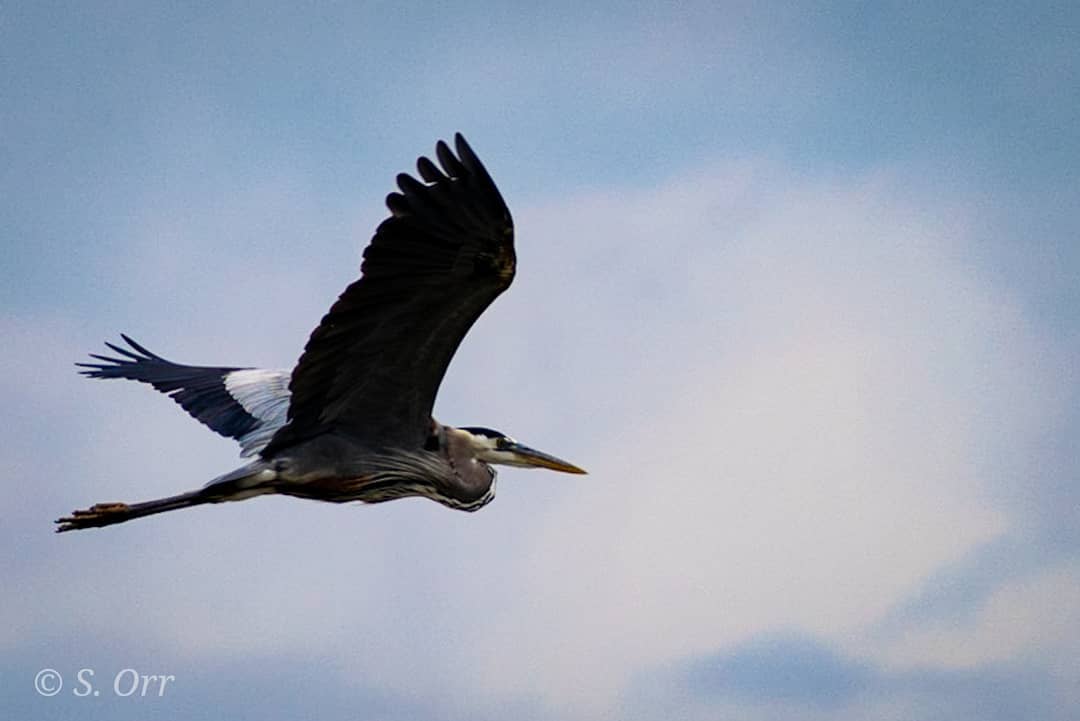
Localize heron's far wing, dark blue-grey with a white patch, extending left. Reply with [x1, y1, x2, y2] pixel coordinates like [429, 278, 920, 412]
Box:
[76, 334, 289, 457]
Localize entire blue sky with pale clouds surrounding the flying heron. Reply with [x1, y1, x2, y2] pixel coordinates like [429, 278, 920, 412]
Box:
[0, 2, 1080, 721]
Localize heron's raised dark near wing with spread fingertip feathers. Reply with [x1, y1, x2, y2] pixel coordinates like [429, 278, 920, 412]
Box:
[262, 134, 515, 455]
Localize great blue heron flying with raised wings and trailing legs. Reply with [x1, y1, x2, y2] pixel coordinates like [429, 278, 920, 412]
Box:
[56, 134, 584, 531]
